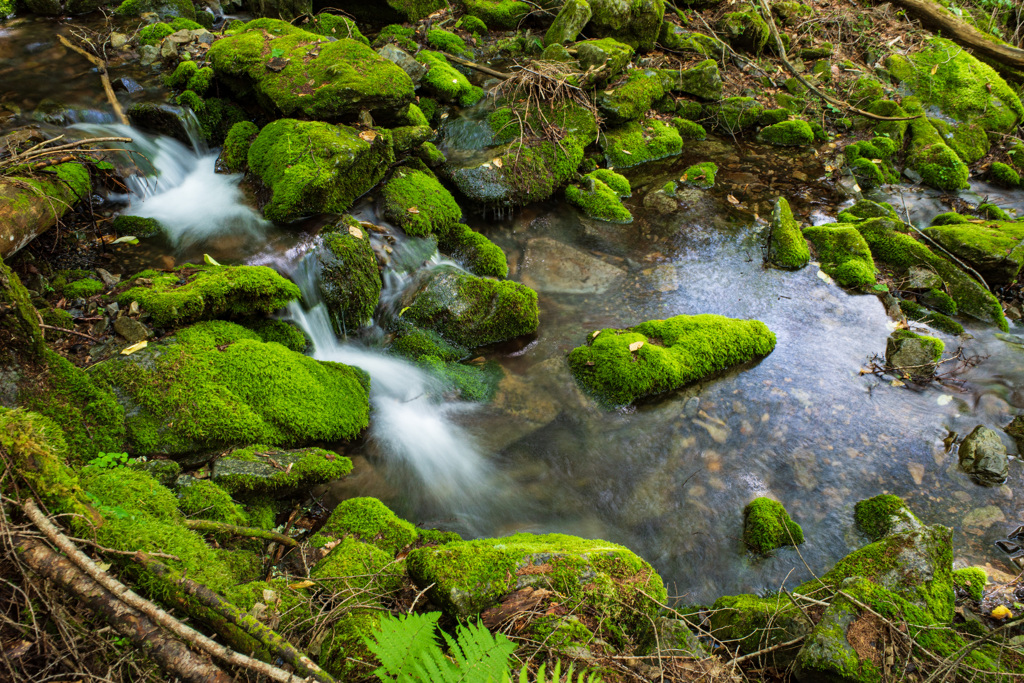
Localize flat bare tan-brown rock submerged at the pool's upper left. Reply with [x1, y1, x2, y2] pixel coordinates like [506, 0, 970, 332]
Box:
[520, 238, 626, 294]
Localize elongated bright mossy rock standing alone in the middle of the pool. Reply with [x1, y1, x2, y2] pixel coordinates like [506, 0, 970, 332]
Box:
[568, 314, 775, 405]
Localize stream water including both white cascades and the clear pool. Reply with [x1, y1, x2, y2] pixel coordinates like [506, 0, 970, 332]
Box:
[6, 25, 1024, 601]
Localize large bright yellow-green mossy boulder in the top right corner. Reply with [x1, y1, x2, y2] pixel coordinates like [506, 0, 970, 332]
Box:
[886, 38, 1024, 163]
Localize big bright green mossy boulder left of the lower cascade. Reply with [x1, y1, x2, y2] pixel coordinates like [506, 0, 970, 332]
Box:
[88, 321, 370, 456]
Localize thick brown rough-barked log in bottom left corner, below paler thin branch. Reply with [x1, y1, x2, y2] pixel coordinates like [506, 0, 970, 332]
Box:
[15, 538, 233, 683]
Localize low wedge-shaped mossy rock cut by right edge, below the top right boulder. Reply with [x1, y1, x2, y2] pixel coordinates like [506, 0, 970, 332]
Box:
[925, 221, 1024, 286]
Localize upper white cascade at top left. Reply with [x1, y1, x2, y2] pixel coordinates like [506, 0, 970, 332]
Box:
[74, 121, 270, 249]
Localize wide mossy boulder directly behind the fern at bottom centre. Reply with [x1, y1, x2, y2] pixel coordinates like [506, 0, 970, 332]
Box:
[406, 533, 666, 645]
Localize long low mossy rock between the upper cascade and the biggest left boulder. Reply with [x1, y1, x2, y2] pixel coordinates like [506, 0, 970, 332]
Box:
[117, 263, 299, 327]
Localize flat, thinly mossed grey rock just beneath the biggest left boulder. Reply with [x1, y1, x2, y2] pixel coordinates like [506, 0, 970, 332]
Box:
[212, 444, 352, 501]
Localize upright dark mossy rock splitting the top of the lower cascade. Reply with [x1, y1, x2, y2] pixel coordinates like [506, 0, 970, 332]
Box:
[315, 217, 382, 327]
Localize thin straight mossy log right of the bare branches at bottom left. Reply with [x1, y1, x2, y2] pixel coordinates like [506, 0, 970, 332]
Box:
[135, 552, 334, 683]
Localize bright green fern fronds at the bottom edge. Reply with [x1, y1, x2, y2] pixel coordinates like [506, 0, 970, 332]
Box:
[366, 612, 515, 683]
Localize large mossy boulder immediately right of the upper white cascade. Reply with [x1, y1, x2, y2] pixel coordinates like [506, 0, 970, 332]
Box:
[248, 119, 394, 221]
